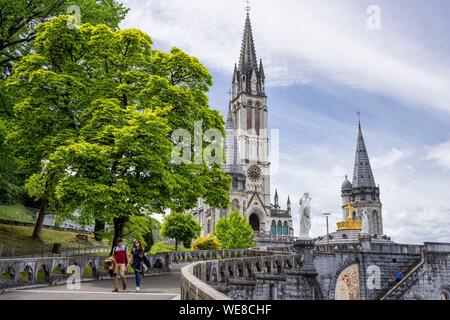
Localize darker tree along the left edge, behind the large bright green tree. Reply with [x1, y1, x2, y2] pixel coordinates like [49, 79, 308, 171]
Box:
[0, 0, 128, 238]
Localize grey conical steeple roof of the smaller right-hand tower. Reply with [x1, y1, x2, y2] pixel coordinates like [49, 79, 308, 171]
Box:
[353, 121, 376, 188]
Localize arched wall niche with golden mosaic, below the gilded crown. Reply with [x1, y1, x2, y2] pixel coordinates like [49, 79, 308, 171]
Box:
[334, 263, 361, 300]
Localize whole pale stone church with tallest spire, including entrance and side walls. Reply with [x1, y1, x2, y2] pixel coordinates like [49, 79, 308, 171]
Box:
[192, 13, 294, 238]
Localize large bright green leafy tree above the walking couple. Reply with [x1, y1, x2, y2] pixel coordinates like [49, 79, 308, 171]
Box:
[9, 17, 230, 237]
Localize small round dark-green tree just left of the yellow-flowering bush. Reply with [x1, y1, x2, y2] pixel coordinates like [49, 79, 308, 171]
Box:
[161, 212, 202, 250]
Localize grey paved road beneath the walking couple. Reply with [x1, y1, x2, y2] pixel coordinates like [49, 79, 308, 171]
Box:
[0, 270, 181, 300]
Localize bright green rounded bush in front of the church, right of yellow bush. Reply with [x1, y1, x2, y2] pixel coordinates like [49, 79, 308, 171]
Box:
[215, 211, 256, 249]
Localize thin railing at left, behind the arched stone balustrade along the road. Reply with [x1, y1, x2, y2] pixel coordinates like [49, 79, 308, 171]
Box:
[0, 244, 111, 259]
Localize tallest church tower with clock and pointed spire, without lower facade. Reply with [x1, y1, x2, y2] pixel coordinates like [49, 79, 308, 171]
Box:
[230, 13, 270, 205]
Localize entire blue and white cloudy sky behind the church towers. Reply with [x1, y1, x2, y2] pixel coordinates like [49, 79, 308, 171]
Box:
[118, 0, 450, 243]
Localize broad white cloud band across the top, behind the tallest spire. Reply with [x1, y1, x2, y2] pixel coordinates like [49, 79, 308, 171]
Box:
[120, 0, 450, 112]
